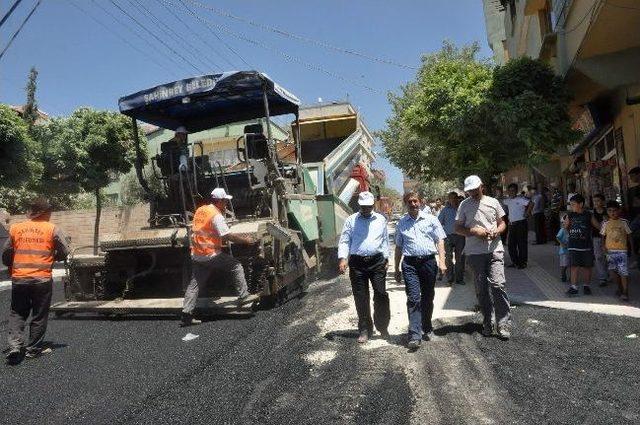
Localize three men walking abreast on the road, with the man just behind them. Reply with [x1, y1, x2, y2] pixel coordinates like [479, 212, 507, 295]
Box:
[338, 175, 511, 350]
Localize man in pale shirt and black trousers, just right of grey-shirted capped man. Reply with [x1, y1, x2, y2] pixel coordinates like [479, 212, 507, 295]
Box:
[502, 183, 533, 269]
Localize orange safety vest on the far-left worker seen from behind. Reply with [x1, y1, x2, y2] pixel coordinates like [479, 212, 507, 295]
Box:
[9, 220, 55, 279]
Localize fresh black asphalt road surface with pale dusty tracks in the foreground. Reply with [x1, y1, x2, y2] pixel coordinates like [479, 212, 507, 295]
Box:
[0, 274, 640, 424]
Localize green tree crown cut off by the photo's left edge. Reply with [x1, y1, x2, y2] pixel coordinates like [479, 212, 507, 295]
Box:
[0, 105, 42, 213]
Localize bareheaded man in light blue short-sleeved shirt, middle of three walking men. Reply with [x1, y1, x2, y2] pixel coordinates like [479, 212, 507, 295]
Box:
[395, 192, 447, 350]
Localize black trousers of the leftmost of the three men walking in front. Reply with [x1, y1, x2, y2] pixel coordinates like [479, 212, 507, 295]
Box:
[349, 254, 391, 333]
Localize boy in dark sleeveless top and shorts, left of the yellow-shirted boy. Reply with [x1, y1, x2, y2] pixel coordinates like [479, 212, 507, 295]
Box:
[565, 194, 600, 296]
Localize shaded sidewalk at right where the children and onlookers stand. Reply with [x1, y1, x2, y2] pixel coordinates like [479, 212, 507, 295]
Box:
[505, 233, 640, 317]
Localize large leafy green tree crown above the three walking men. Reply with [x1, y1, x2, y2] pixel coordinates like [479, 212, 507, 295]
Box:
[378, 42, 579, 181]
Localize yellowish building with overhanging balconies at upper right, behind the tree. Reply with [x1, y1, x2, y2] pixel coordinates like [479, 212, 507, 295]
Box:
[484, 0, 640, 203]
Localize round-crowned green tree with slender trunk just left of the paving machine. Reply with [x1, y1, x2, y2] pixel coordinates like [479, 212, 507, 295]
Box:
[50, 108, 146, 253]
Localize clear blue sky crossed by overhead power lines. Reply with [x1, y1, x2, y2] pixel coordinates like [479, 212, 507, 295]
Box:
[0, 0, 490, 191]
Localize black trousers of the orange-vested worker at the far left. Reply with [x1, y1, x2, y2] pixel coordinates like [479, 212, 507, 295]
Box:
[9, 280, 52, 352]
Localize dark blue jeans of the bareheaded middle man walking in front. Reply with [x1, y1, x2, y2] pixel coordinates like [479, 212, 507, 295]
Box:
[402, 257, 438, 341]
